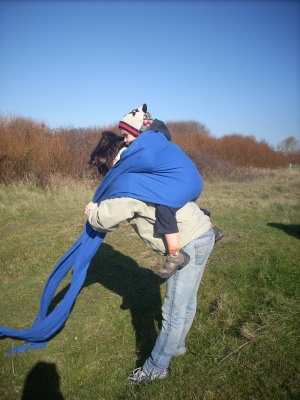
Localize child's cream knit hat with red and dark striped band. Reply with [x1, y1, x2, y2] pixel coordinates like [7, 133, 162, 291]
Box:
[119, 104, 153, 136]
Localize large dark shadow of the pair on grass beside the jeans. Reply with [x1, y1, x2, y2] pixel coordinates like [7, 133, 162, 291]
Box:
[49, 243, 165, 367]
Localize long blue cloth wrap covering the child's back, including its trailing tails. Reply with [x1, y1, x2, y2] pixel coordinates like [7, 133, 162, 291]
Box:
[0, 131, 202, 354]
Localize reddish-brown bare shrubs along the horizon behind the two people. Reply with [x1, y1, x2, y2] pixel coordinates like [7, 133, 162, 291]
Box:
[0, 117, 300, 187]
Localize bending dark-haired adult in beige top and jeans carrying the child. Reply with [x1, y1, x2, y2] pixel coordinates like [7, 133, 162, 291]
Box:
[85, 134, 215, 384]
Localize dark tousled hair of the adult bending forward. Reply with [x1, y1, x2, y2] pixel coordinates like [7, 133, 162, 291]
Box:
[89, 131, 126, 176]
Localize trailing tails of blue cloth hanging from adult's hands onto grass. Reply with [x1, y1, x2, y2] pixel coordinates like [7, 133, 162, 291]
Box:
[0, 223, 105, 354]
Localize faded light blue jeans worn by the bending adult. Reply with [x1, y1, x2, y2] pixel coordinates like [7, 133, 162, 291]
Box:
[142, 229, 215, 376]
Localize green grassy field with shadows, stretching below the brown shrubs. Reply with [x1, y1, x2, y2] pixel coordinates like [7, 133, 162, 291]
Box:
[0, 170, 300, 400]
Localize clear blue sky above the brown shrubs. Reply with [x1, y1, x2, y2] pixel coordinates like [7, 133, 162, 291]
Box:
[0, 0, 300, 146]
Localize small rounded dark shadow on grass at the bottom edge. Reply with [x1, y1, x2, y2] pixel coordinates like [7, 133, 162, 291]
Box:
[22, 362, 64, 400]
